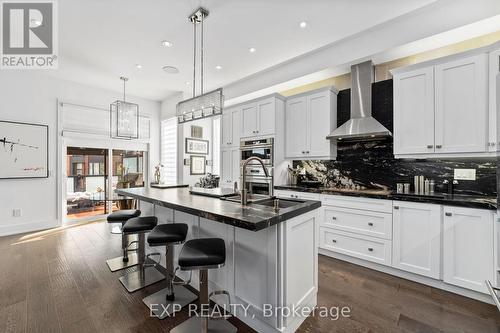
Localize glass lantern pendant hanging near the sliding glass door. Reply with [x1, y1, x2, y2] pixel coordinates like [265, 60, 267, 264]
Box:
[110, 76, 139, 140]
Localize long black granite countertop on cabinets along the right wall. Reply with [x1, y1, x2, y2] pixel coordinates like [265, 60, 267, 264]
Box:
[274, 185, 497, 210]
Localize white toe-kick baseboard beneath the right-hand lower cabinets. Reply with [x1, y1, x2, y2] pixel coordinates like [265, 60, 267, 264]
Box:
[319, 248, 494, 304]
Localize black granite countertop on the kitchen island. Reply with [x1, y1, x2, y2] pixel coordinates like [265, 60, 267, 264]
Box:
[115, 187, 321, 231]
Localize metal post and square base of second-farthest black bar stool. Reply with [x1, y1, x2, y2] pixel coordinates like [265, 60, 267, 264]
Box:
[119, 233, 165, 293]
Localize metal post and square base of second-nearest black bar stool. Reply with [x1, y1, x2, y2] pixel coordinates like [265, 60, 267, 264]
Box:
[142, 244, 198, 319]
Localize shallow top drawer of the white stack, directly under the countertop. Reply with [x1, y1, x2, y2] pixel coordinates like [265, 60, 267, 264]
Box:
[322, 194, 392, 213]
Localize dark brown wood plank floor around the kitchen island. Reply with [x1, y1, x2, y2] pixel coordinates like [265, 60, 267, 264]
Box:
[0, 218, 500, 333]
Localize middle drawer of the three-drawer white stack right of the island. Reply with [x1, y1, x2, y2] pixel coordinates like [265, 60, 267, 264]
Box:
[322, 206, 392, 240]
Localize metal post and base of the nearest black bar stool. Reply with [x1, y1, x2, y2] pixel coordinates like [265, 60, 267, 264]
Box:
[170, 269, 237, 333]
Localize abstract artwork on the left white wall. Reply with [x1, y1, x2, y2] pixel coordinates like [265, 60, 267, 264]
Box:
[0, 120, 49, 179]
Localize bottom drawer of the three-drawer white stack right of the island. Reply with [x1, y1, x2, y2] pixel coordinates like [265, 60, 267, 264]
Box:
[320, 227, 391, 266]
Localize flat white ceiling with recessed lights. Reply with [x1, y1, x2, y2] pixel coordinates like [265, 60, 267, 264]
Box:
[52, 0, 434, 100]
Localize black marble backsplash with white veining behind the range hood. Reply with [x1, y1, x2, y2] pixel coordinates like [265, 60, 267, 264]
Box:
[293, 80, 497, 196]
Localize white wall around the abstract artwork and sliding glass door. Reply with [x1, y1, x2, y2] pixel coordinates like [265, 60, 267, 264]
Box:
[0, 71, 160, 236]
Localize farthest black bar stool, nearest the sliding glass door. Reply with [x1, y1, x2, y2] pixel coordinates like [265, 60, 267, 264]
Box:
[106, 209, 141, 272]
